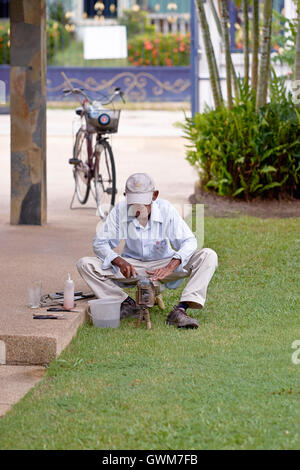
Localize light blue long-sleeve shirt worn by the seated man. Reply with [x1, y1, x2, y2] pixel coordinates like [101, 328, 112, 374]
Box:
[93, 199, 197, 278]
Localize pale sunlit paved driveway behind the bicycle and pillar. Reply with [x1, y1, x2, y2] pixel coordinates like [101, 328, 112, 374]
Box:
[0, 110, 197, 221]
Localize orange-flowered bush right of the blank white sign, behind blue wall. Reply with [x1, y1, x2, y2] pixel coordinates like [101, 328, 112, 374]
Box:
[128, 34, 190, 67]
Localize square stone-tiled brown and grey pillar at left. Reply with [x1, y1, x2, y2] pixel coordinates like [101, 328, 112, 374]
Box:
[10, 0, 47, 225]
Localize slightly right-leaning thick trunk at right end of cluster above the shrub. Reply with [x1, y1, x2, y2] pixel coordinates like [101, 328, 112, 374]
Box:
[256, 0, 273, 111]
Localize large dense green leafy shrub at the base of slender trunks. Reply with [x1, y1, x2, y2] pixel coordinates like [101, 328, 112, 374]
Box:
[182, 75, 300, 200]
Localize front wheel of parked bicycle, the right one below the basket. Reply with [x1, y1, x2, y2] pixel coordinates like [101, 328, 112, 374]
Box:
[94, 140, 117, 219]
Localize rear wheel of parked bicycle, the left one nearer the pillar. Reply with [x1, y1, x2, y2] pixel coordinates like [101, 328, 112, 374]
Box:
[73, 129, 92, 204]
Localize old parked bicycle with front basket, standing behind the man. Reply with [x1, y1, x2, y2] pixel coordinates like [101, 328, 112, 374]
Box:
[63, 82, 125, 219]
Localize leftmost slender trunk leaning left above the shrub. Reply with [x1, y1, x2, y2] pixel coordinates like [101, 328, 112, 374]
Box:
[197, 0, 223, 108]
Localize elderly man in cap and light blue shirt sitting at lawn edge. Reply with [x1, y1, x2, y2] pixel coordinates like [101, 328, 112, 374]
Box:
[77, 173, 218, 328]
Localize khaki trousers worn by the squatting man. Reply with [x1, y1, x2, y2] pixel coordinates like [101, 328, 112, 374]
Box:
[77, 248, 218, 309]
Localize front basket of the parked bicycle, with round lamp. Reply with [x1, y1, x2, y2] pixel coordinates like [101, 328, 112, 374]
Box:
[87, 108, 121, 134]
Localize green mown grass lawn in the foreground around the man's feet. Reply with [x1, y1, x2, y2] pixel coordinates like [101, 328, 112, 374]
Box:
[0, 217, 300, 449]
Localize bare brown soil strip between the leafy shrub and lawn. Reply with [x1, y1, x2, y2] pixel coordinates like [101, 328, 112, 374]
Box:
[189, 186, 300, 219]
